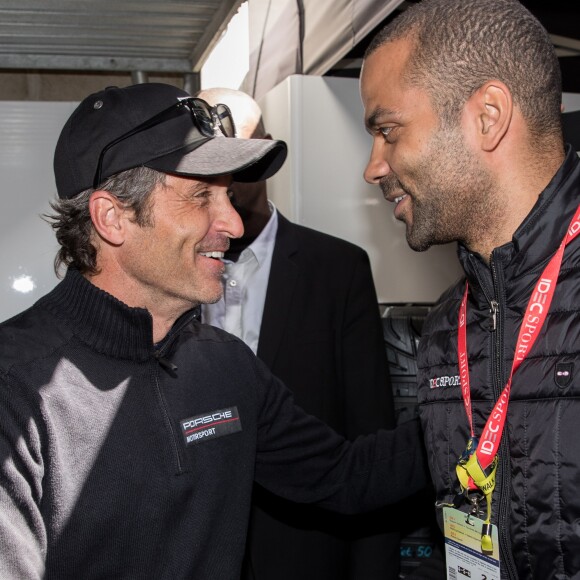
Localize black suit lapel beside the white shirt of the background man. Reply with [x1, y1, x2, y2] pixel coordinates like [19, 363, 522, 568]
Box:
[258, 212, 298, 368]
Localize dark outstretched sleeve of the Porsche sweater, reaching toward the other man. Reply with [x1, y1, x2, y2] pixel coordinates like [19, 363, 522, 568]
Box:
[256, 361, 427, 514]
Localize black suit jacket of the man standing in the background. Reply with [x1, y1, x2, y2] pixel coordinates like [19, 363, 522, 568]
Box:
[243, 214, 399, 580]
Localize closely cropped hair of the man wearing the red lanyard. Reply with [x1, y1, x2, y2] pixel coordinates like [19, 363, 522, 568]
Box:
[365, 0, 562, 139]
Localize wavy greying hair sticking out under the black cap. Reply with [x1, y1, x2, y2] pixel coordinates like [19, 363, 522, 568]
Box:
[44, 167, 165, 276]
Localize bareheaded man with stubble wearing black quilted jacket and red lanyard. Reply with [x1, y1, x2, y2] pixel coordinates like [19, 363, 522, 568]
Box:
[361, 0, 580, 580]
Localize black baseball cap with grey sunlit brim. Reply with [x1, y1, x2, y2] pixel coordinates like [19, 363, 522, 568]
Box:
[54, 83, 287, 198]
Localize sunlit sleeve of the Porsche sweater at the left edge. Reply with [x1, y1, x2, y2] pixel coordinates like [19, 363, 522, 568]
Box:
[0, 384, 46, 580]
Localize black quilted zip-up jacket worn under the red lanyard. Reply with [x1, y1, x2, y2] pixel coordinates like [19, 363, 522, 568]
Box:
[419, 148, 580, 580]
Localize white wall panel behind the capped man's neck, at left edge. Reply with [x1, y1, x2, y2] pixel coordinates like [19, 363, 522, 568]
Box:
[0, 101, 76, 321]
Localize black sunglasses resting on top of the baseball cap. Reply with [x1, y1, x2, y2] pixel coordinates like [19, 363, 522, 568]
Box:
[93, 97, 236, 189]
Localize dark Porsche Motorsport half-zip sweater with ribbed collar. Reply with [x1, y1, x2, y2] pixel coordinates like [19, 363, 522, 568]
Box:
[0, 270, 426, 580]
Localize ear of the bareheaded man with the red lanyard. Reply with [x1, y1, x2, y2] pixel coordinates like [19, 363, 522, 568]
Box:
[468, 81, 513, 151]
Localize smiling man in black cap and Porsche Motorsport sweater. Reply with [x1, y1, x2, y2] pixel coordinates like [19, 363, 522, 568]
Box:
[0, 84, 425, 580]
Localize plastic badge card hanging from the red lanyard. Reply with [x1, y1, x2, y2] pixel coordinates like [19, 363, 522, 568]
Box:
[443, 507, 500, 580]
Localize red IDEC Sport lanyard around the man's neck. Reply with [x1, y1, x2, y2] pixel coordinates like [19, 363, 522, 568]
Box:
[457, 206, 580, 470]
